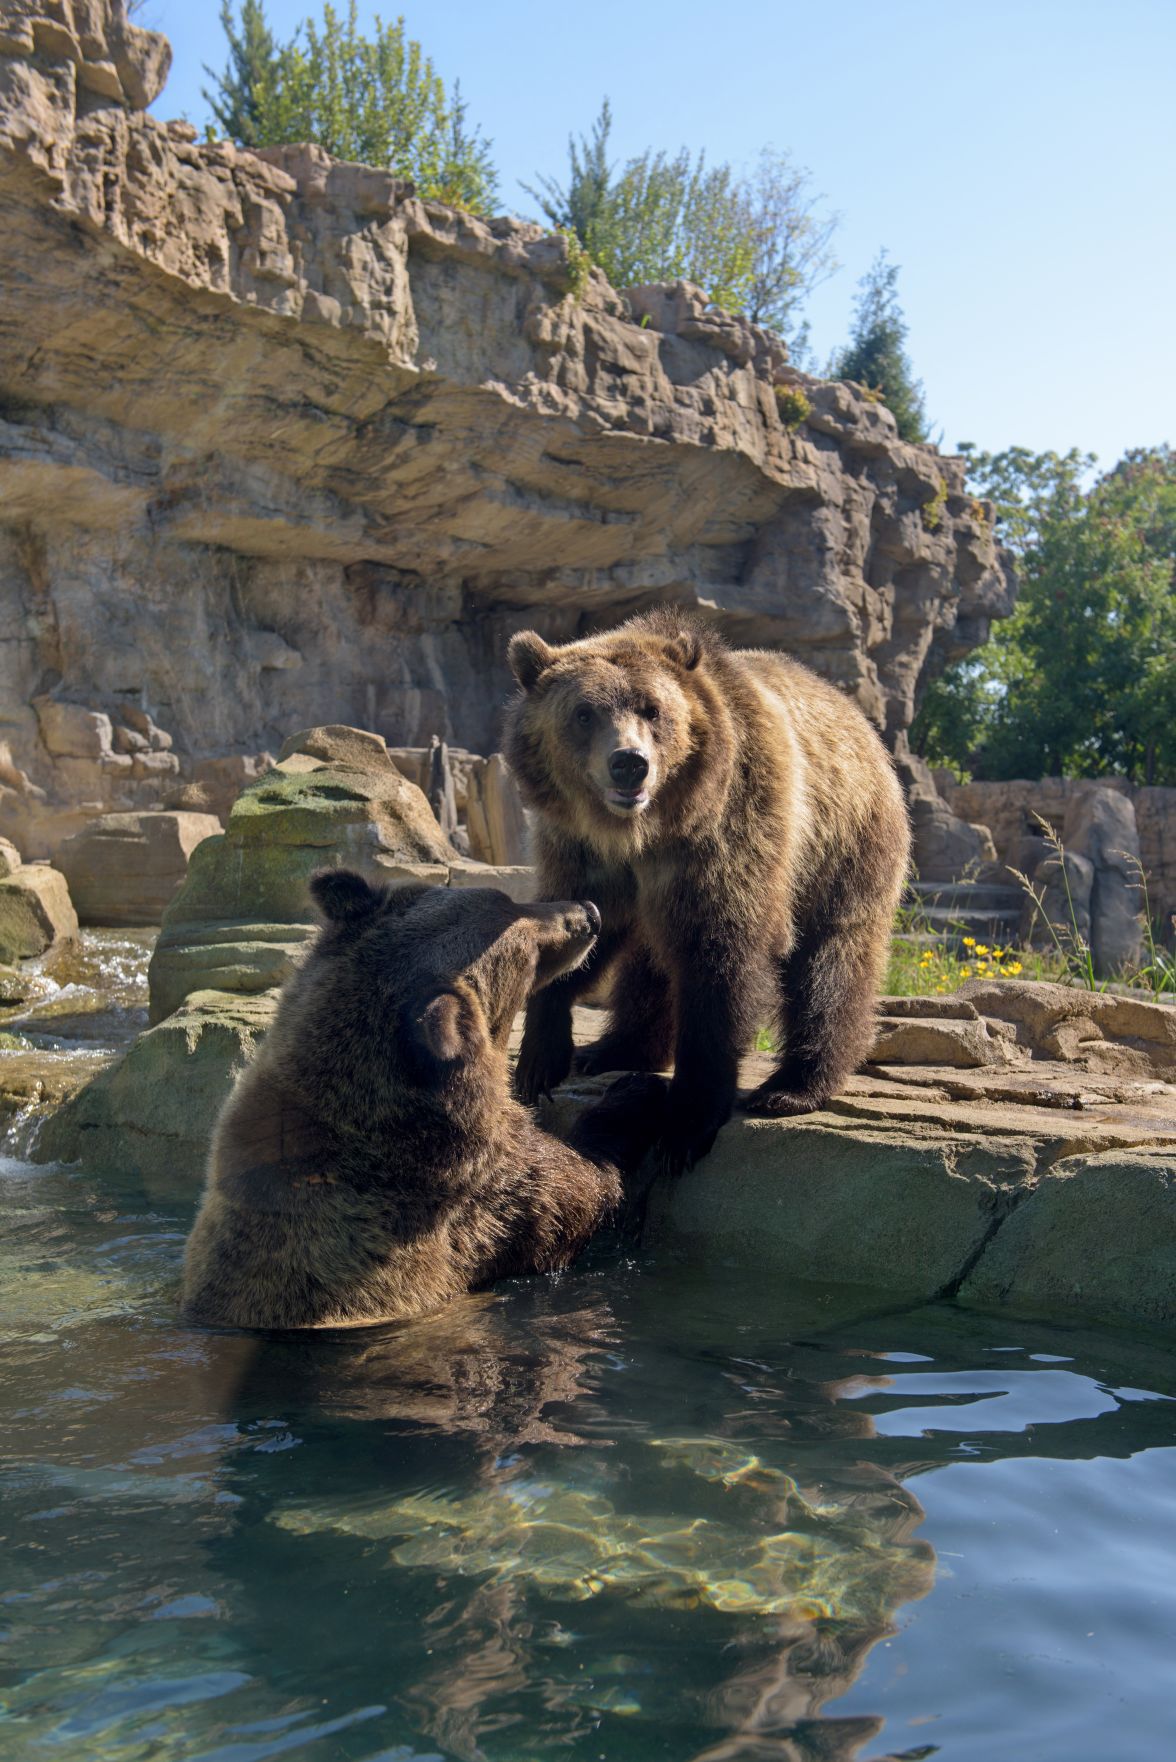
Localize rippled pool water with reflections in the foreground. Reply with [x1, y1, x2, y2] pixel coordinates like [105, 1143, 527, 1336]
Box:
[0, 1161, 1176, 1762]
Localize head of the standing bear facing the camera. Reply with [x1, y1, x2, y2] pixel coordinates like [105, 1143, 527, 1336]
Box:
[506, 613, 732, 848]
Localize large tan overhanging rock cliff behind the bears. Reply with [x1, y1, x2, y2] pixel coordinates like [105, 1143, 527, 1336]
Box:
[0, 0, 1012, 855]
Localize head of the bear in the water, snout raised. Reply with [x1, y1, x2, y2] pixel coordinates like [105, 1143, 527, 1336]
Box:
[266, 869, 599, 1135]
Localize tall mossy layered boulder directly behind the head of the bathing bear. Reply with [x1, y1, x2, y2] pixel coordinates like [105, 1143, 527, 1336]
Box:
[150, 726, 455, 1022]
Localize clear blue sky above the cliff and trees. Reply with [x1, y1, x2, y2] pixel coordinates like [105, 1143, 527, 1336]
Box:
[141, 0, 1176, 465]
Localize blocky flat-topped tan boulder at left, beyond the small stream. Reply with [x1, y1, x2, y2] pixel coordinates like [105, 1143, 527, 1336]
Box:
[53, 812, 220, 927]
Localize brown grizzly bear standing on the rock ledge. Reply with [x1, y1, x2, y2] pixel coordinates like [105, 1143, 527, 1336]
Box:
[506, 608, 910, 1172]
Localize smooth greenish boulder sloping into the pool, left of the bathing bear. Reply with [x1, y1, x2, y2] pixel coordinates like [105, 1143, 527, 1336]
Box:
[28, 990, 275, 1189]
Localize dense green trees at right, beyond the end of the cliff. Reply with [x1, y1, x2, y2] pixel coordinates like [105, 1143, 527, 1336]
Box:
[912, 448, 1176, 782]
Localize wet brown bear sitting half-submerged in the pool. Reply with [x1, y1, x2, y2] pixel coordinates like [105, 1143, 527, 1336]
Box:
[183, 869, 666, 1329]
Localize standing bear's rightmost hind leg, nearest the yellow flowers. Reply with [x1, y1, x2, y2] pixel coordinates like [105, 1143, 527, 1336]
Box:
[744, 911, 892, 1119]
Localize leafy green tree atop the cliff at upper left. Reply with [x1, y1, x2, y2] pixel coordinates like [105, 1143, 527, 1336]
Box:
[205, 0, 495, 211]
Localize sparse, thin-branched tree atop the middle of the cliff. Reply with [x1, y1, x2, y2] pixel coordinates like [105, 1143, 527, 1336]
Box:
[524, 99, 836, 335]
